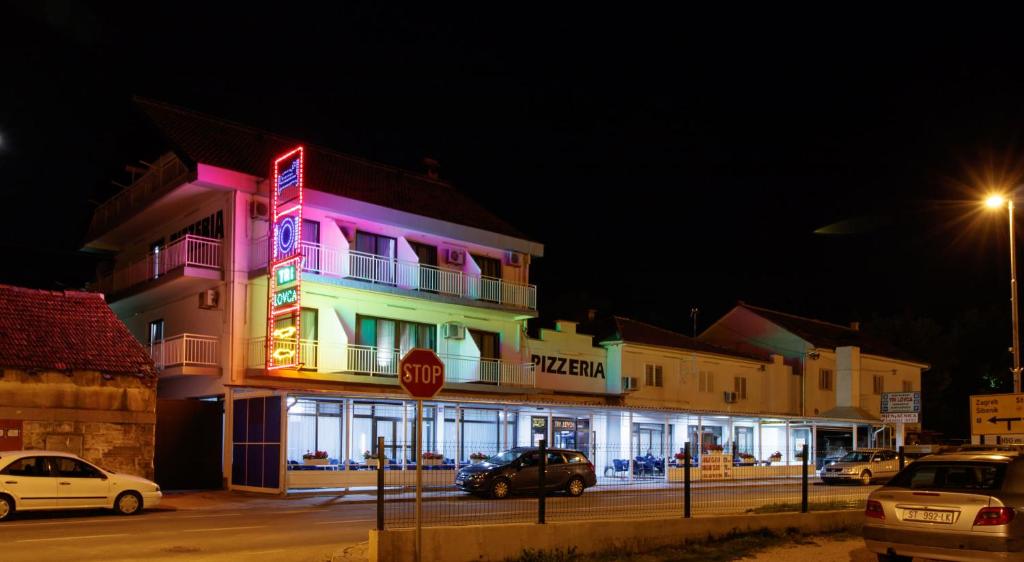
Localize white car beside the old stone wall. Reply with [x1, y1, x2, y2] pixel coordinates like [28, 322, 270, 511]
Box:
[0, 450, 163, 521]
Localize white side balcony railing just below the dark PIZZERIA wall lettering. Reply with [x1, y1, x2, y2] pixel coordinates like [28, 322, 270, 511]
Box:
[97, 234, 221, 294]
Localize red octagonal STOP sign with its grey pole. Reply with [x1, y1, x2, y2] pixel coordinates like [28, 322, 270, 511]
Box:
[398, 347, 444, 562]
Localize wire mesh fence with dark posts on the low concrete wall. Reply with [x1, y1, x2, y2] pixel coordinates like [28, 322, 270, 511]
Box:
[367, 443, 888, 528]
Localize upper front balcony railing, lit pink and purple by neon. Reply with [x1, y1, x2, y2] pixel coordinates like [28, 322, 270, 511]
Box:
[249, 237, 537, 310]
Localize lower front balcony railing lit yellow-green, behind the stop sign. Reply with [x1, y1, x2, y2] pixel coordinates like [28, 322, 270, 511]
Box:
[247, 338, 537, 388]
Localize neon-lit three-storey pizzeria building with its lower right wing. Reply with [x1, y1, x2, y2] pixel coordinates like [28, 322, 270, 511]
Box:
[86, 101, 920, 492]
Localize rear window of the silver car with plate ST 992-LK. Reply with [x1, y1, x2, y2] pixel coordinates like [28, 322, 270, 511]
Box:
[887, 461, 1007, 490]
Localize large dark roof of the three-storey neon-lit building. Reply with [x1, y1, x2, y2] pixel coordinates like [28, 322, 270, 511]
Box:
[135, 98, 527, 240]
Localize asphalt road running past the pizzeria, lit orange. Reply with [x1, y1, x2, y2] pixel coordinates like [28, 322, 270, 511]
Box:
[0, 482, 876, 562]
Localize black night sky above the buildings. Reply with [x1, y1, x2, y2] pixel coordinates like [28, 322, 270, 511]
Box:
[0, 1, 1024, 433]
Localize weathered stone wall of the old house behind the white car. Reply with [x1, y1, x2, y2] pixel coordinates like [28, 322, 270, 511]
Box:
[0, 370, 157, 479]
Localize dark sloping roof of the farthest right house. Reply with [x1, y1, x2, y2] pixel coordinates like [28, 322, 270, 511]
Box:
[736, 302, 927, 364]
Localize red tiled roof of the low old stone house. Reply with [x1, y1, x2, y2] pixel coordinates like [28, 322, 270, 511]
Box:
[0, 285, 156, 377]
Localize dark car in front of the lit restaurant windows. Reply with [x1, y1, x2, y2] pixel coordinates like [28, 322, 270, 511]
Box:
[455, 447, 597, 499]
